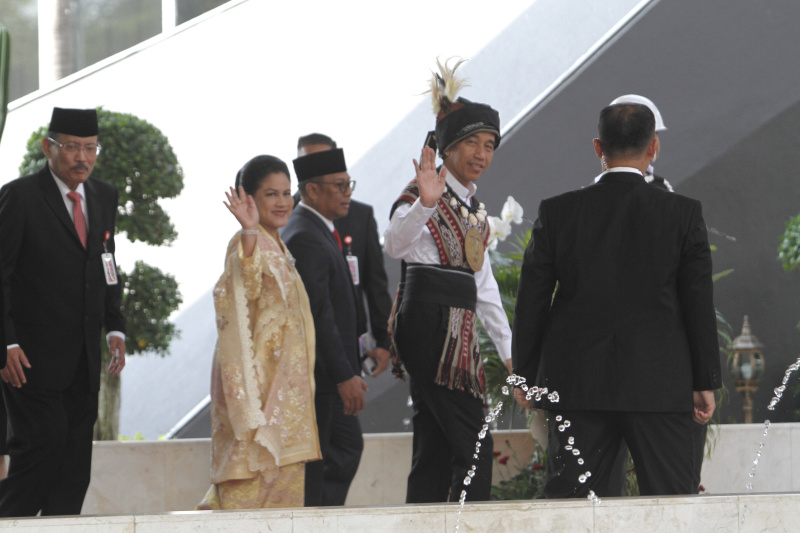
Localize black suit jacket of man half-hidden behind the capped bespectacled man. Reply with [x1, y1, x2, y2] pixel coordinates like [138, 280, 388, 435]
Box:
[333, 200, 392, 350]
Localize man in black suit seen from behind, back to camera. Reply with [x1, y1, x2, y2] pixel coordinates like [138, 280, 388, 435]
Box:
[513, 104, 721, 498]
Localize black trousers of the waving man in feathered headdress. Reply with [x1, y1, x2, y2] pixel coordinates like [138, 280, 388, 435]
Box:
[395, 301, 493, 503]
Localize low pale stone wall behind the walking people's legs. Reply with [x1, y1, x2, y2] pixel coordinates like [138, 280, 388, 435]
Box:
[83, 424, 800, 514]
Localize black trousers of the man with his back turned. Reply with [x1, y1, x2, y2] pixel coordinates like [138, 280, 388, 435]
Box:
[545, 411, 694, 498]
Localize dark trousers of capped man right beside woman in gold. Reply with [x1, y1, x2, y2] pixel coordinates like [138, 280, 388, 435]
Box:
[305, 392, 364, 507]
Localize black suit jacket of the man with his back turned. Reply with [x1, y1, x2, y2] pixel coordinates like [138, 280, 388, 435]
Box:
[513, 172, 721, 412]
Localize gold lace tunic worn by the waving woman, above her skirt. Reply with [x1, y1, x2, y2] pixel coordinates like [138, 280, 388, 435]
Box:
[211, 228, 321, 483]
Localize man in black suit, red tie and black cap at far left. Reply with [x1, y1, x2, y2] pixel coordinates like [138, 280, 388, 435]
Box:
[0, 108, 125, 517]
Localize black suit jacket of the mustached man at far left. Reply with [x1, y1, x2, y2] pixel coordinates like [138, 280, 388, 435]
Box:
[0, 166, 125, 391]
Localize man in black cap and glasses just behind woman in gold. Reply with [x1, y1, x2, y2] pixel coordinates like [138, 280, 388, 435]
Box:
[282, 149, 367, 507]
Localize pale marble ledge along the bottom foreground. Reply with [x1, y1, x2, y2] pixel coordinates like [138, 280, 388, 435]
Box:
[0, 493, 800, 533]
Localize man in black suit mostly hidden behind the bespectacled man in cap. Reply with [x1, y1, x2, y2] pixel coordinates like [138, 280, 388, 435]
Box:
[297, 133, 392, 377]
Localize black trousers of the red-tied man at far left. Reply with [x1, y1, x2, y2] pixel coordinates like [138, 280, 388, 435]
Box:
[0, 358, 97, 517]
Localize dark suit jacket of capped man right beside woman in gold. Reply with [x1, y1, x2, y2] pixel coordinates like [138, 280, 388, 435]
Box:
[281, 206, 360, 393]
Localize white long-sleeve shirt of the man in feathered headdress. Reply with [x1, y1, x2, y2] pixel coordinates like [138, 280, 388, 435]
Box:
[383, 174, 511, 361]
